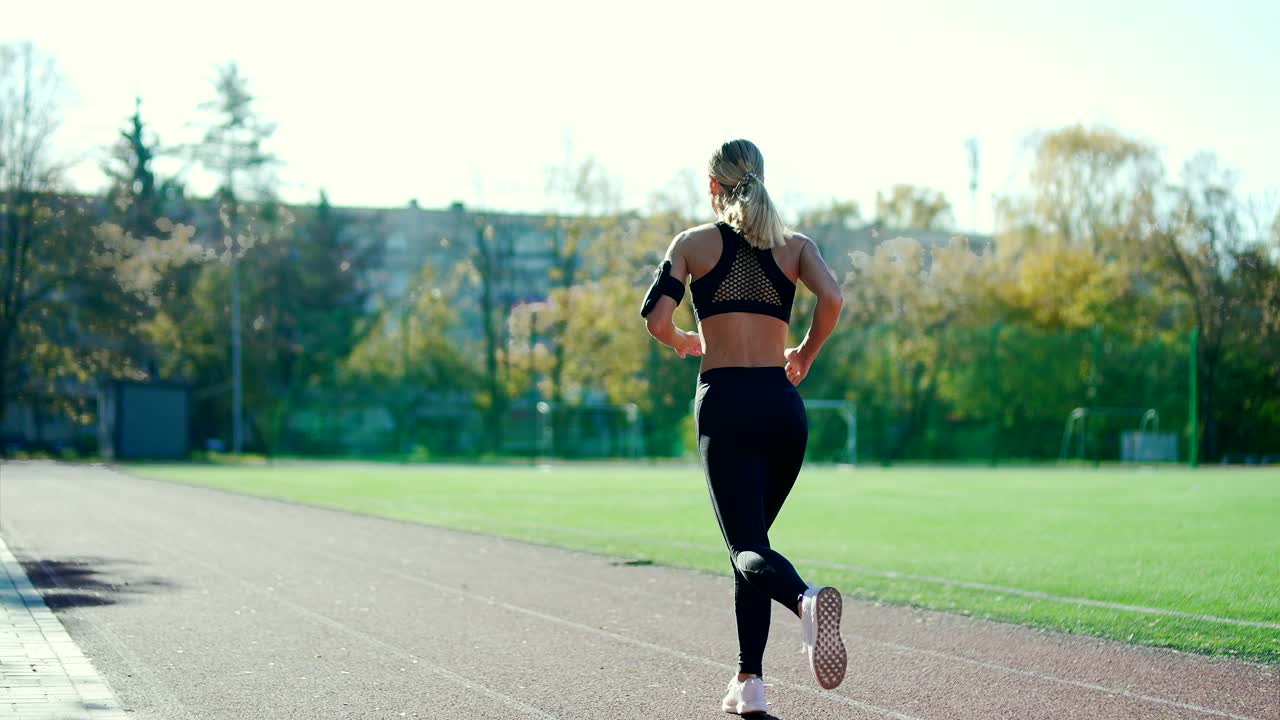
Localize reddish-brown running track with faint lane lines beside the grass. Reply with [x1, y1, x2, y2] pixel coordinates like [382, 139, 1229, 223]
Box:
[0, 464, 1280, 720]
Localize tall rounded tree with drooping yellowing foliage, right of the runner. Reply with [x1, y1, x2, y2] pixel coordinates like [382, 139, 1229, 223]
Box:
[975, 126, 1161, 445]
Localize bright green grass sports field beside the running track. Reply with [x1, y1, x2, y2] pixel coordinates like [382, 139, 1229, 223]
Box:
[122, 464, 1280, 662]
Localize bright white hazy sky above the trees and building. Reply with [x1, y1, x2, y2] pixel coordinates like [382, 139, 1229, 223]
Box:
[10, 0, 1280, 229]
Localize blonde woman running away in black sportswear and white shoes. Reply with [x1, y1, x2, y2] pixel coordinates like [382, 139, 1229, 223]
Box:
[640, 140, 847, 715]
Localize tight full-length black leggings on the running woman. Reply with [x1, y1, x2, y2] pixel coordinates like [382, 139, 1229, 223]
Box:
[694, 368, 809, 675]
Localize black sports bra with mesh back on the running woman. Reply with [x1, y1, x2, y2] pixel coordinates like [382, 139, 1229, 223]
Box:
[689, 223, 796, 323]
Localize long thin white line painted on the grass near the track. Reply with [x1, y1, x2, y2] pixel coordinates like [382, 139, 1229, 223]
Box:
[371, 505, 1280, 630]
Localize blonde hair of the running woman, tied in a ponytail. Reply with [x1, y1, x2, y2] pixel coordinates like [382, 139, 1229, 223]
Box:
[707, 140, 787, 250]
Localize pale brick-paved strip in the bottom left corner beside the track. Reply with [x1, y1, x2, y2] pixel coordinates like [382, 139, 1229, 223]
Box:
[0, 537, 127, 720]
